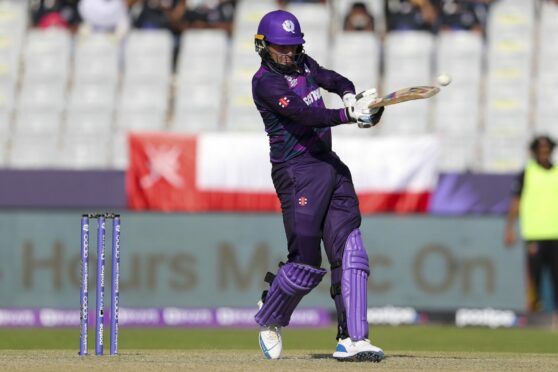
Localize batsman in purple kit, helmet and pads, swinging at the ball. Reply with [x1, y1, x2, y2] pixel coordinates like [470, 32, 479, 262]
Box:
[252, 10, 384, 362]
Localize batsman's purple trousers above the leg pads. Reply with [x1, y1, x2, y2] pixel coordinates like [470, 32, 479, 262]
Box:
[271, 152, 361, 267]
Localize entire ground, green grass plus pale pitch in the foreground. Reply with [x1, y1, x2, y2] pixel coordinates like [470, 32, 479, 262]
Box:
[0, 326, 558, 372]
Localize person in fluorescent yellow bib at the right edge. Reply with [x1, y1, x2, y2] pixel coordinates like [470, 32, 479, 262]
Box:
[504, 136, 558, 329]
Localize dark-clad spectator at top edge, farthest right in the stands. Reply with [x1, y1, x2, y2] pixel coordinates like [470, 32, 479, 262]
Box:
[436, 0, 483, 32]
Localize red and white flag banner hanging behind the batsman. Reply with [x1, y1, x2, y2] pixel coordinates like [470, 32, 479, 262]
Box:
[127, 133, 438, 213]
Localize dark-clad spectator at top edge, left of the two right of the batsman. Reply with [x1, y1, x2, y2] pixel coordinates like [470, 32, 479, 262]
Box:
[384, 0, 437, 32]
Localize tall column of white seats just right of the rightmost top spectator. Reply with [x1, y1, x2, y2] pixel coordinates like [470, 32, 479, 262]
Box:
[481, 0, 535, 172]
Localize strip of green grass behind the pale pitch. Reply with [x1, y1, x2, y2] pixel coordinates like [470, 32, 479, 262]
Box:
[0, 326, 558, 355]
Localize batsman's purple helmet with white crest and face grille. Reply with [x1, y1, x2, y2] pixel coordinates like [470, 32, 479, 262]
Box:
[254, 10, 305, 74]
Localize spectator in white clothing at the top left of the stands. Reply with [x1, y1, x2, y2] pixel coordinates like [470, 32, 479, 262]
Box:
[78, 0, 130, 37]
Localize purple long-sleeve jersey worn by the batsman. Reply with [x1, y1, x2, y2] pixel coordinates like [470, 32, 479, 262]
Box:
[252, 55, 355, 163]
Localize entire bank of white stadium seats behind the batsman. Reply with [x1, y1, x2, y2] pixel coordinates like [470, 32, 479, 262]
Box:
[0, 0, 558, 172]
